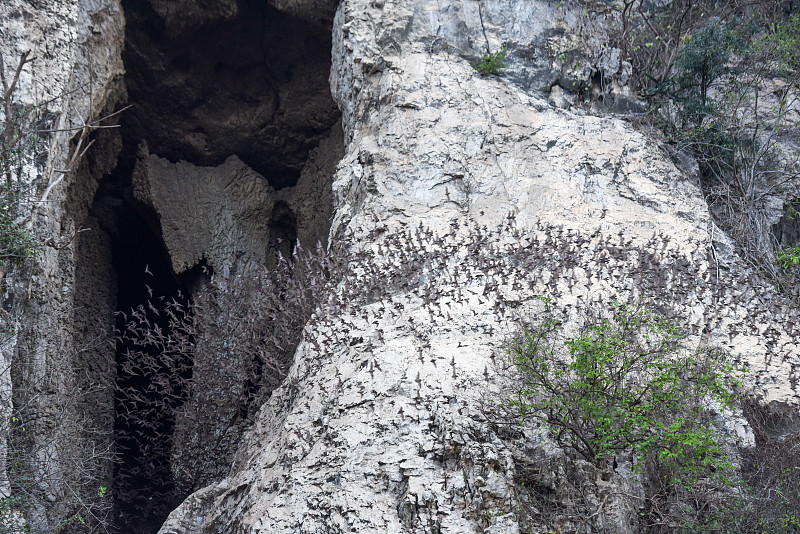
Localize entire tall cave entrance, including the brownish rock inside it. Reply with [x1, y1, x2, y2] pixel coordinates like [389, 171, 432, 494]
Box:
[86, 0, 343, 533]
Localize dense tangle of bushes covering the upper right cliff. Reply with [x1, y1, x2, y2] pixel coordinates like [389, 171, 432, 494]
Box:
[618, 0, 800, 287]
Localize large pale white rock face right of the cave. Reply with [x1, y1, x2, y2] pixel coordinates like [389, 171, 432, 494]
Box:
[155, 0, 800, 534]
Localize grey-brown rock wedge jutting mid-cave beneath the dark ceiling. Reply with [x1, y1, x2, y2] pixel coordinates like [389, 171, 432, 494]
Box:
[133, 123, 342, 280]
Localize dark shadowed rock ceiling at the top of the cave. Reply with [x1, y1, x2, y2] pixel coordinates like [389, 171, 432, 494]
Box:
[123, 0, 339, 188]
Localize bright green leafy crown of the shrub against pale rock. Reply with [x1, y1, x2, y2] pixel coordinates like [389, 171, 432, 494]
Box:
[508, 300, 738, 483]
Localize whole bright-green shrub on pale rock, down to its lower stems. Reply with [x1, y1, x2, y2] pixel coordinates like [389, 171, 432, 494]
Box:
[505, 299, 739, 531]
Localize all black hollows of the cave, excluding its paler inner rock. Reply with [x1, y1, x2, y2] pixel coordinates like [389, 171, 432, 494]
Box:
[79, 0, 341, 533]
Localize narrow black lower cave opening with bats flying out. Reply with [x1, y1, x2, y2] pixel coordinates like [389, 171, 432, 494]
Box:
[91, 173, 198, 532]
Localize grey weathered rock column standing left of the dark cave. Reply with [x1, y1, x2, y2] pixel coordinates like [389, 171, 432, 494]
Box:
[0, 0, 124, 530]
